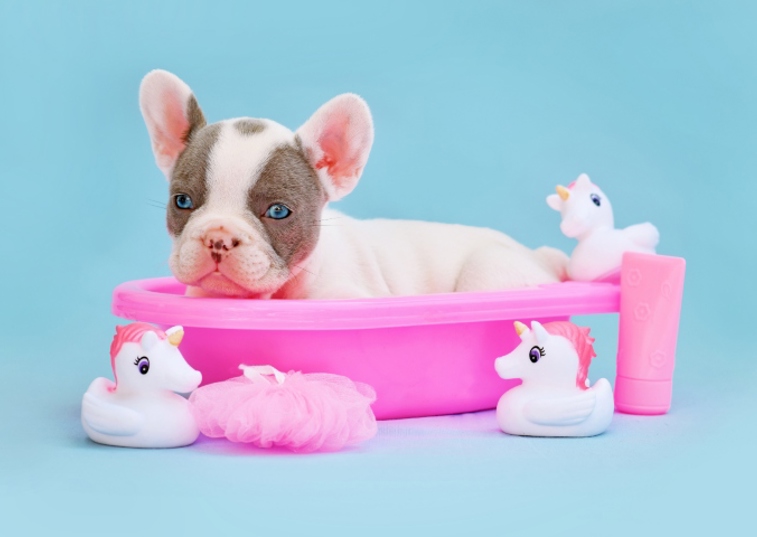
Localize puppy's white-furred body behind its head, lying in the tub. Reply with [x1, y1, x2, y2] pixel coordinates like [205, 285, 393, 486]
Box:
[278, 209, 565, 298]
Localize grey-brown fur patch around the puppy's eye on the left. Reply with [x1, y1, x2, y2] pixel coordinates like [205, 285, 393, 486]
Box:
[166, 125, 221, 237]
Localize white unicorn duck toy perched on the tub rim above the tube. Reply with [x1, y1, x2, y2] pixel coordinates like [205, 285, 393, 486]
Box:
[547, 173, 660, 281]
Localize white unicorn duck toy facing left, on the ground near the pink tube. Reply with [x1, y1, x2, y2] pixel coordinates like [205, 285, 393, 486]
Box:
[494, 321, 614, 436]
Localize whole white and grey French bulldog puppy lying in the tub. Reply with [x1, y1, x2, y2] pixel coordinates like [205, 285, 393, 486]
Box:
[140, 70, 567, 299]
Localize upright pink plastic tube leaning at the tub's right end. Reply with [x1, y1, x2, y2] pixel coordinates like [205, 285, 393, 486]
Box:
[615, 252, 686, 415]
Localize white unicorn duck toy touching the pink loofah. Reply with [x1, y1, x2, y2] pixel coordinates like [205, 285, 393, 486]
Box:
[81, 323, 202, 448]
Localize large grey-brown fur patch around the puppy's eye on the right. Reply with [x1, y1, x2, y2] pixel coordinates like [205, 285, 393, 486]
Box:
[248, 145, 326, 267]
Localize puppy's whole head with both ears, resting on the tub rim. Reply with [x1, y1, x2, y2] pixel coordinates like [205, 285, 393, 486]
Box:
[140, 70, 373, 297]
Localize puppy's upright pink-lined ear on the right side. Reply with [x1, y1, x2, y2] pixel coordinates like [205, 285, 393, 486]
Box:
[297, 93, 373, 201]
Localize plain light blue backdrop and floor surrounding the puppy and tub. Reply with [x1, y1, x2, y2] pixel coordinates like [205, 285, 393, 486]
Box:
[0, 0, 757, 535]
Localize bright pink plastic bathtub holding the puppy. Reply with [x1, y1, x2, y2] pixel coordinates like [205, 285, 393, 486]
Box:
[113, 278, 620, 419]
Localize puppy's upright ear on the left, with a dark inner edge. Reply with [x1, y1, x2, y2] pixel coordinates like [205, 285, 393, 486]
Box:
[139, 69, 206, 179]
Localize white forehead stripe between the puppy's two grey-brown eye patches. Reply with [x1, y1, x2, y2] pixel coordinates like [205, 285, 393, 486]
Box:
[208, 118, 294, 209]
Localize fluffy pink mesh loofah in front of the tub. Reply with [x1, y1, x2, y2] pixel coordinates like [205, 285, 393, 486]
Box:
[189, 366, 377, 451]
